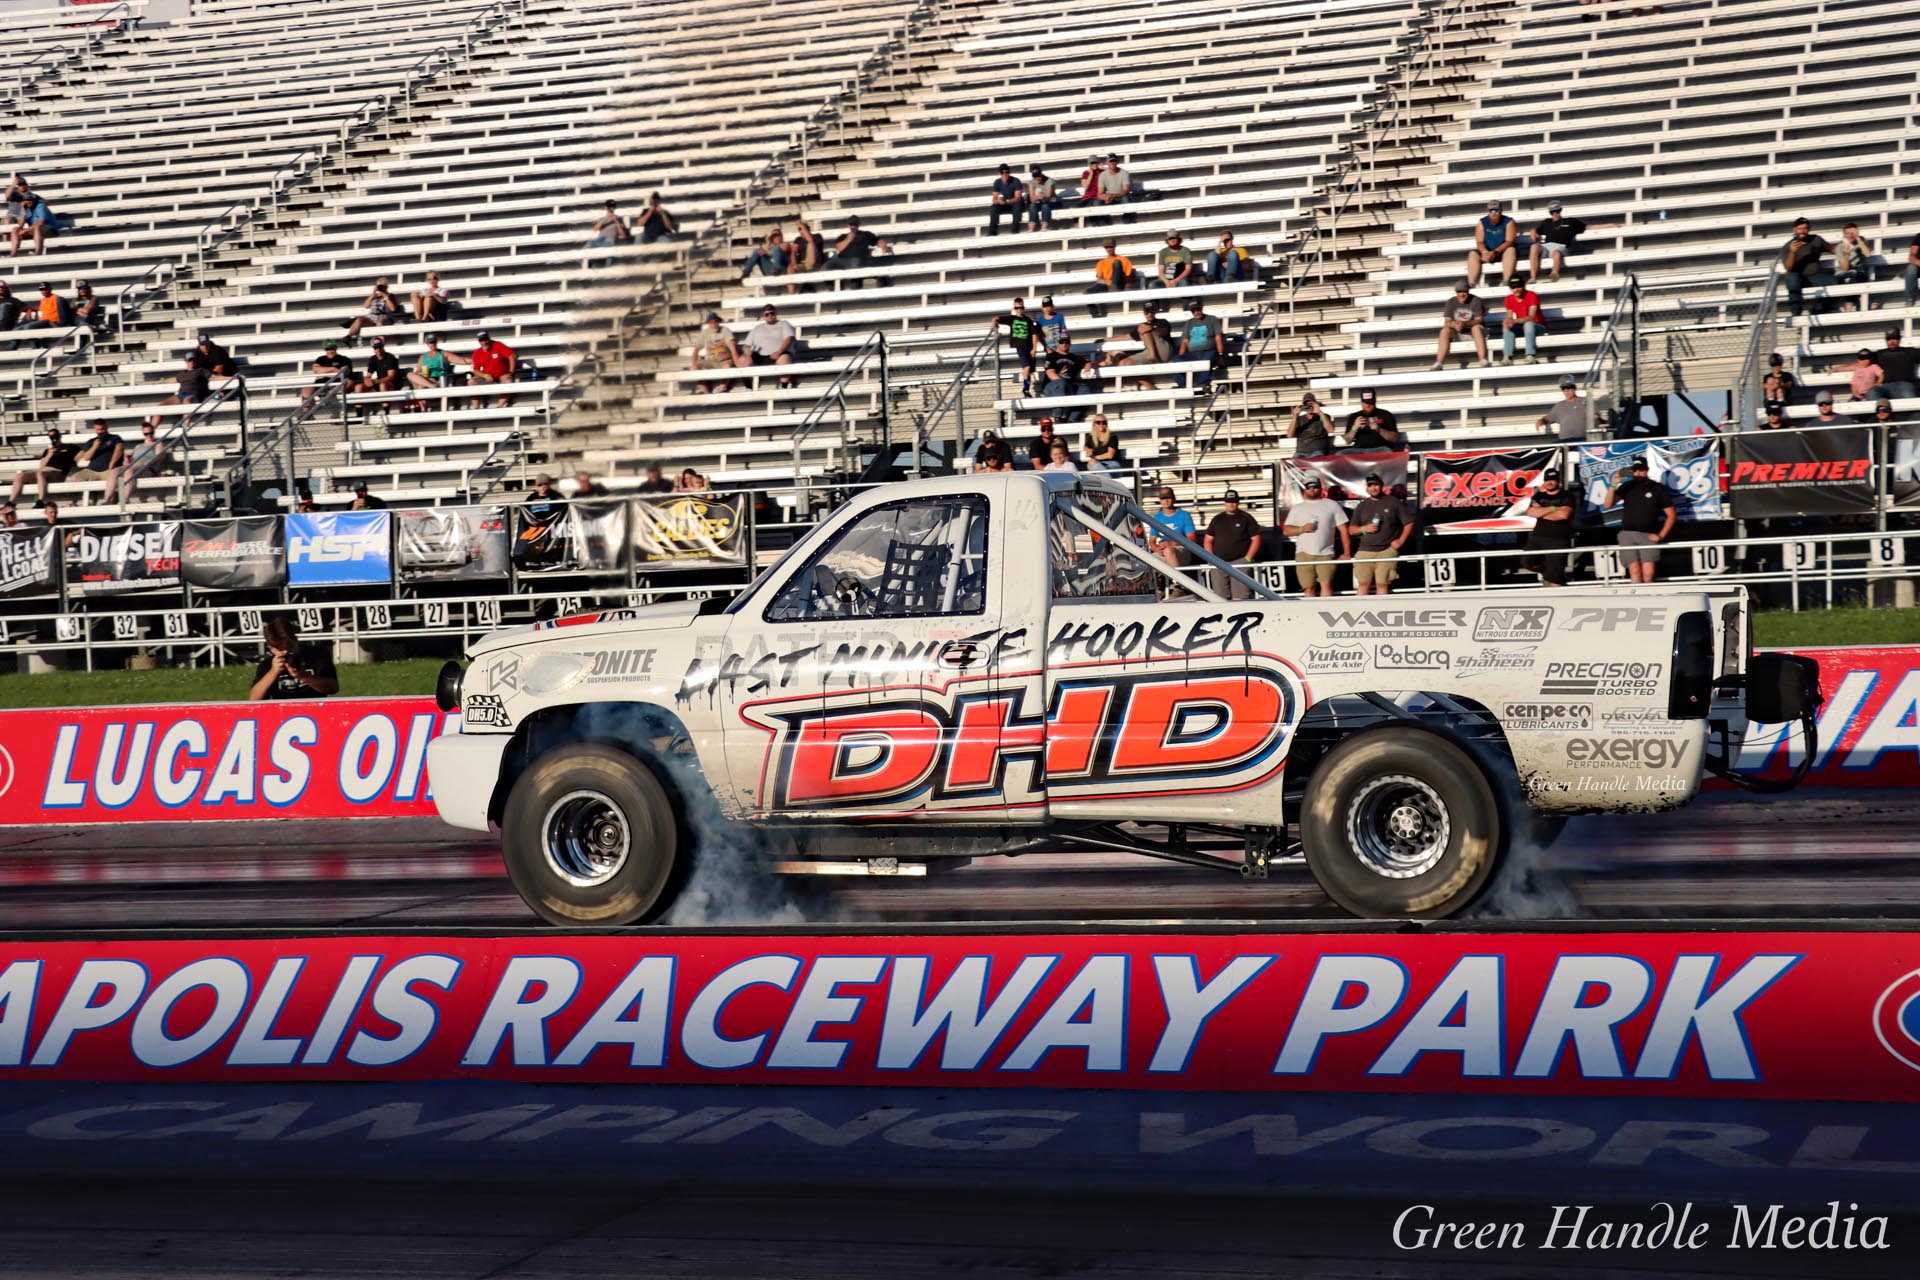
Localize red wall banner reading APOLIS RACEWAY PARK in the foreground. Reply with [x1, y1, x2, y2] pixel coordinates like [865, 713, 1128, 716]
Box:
[0, 931, 1920, 1102]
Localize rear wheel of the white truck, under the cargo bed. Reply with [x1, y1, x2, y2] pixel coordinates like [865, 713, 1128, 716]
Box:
[1300, 725, 1501, 919]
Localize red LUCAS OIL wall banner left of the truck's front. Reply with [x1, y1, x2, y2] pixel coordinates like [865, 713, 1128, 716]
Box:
[0, 694, 457, 825]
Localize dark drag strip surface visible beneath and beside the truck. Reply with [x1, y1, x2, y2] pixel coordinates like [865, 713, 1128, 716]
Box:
[0, 791, 1920, 931]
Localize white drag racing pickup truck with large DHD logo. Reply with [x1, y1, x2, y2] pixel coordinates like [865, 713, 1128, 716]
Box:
[428, 472, 1820, 925]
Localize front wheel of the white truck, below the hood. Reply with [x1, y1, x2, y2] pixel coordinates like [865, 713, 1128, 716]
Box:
[499, 743, 687, 925]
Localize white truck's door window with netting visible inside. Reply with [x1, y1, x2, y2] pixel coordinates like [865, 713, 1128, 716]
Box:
[766, 493, 987, 622]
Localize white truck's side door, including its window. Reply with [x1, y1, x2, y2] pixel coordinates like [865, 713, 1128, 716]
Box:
[722, 491, 1044, 819]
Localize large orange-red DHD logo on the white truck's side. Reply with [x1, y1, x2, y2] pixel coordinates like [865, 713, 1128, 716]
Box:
[747, 664, 1304, 810]
